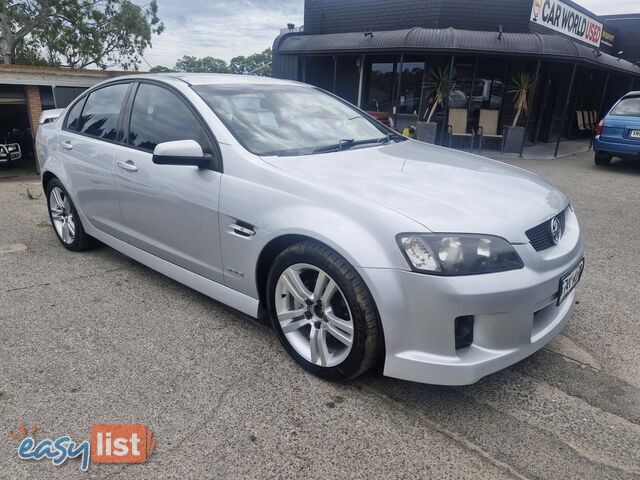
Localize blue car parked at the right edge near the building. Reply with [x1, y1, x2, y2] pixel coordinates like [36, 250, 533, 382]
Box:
[593, 91, 640, 165]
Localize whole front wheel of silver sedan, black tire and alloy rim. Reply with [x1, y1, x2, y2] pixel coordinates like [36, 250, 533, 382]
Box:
[266, 241, 384, 381]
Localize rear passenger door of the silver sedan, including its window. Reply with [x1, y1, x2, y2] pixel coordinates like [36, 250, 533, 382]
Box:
[59, 82, 131, 235]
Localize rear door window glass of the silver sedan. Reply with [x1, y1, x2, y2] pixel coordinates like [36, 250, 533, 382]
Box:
[79, 83, 129, 140]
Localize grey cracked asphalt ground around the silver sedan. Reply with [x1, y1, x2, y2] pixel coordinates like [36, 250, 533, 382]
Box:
[0, 154, 640, 480]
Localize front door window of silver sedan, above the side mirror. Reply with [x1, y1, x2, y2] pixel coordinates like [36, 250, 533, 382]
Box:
[129, 83, 213, 154]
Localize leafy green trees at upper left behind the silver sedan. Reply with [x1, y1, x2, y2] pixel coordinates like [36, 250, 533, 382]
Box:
[0, 0, 164, 70]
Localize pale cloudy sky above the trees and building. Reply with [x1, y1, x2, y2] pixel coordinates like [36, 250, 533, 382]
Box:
[136, 0, 640, 70]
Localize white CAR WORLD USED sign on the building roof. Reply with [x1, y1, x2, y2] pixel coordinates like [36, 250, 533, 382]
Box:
[531, 0, 602, 47]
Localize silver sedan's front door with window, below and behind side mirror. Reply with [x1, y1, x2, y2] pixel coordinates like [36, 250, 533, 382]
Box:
[115, 83, 223, 282]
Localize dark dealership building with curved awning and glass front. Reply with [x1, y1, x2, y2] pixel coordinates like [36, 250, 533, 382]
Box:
[273, 0, 640, 151]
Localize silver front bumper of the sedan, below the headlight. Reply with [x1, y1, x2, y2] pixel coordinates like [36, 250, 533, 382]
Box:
[359, 208, 584, 385]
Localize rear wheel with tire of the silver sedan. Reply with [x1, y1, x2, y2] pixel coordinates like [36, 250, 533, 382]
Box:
[47, 178, 95, 252]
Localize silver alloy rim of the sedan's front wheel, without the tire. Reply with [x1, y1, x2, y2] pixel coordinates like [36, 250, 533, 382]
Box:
[275, 263, 354, 367]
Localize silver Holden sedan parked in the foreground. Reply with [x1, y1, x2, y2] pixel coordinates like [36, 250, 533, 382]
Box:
[37, 74, 584, 385]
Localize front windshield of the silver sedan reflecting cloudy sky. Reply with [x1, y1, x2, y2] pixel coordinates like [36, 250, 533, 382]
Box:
[193, 85, 396, 156]
